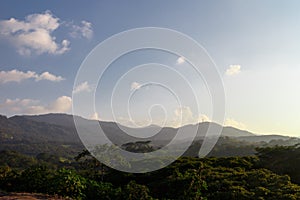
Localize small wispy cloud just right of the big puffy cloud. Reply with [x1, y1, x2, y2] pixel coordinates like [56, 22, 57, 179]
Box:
[70, 20, 93, 39]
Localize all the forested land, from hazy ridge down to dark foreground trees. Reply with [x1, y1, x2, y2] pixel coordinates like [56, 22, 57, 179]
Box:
[0, 114, 300, 200]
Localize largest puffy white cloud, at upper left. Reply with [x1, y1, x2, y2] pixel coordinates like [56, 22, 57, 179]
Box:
[0, 11, 70, 55]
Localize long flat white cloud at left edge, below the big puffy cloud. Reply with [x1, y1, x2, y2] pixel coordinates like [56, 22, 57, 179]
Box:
[0, 69, 64, 83]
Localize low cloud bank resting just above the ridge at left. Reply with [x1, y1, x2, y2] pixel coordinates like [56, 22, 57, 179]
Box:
[0, 96, 72, 114]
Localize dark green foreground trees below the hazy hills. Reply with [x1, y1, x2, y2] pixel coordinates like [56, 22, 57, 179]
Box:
[0, 145, 300, 200]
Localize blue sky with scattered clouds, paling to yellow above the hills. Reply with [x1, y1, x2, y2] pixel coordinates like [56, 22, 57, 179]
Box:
[0, 0, 300, 137]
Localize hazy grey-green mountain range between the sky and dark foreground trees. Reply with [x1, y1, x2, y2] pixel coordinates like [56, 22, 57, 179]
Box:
[0, 114, 300, 156]
